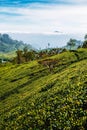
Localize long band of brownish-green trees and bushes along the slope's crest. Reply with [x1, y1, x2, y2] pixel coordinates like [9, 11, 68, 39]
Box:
[12, 47, 64, 64]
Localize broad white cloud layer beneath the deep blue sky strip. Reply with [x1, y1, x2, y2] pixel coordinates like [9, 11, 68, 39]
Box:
[0, 4, 87, 33]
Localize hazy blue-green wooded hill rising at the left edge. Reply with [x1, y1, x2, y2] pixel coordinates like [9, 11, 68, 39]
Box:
[0, 34, 33, 53]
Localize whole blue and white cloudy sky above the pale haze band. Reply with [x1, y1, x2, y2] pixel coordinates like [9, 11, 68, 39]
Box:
[0, 0, 87, 34]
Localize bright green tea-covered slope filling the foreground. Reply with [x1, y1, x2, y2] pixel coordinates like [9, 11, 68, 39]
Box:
[0, 49, 87, 130]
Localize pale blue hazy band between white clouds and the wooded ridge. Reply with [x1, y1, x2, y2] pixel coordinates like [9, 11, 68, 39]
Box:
[9, 33, 84, 49]
